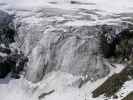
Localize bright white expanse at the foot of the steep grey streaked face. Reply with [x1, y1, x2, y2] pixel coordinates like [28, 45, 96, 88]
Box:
[0, 65, 127, 100]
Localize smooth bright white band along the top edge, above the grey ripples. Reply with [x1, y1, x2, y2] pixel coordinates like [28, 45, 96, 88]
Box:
[0, 0, 133, 15]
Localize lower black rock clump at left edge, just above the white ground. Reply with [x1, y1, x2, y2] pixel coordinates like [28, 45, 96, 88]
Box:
[0, 48, 28, 78]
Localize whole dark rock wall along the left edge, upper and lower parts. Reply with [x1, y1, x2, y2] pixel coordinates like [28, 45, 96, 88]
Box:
[0, 11, 28, 78]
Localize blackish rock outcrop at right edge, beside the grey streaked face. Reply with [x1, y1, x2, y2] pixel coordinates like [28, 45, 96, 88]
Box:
[99, 25, 133, 58]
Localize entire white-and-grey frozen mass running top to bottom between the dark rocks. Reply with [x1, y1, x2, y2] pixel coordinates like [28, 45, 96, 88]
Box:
[0, 0, 133, 100]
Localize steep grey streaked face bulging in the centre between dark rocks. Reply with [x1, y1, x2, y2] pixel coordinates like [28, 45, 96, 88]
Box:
[24, 24, 109, 82]
